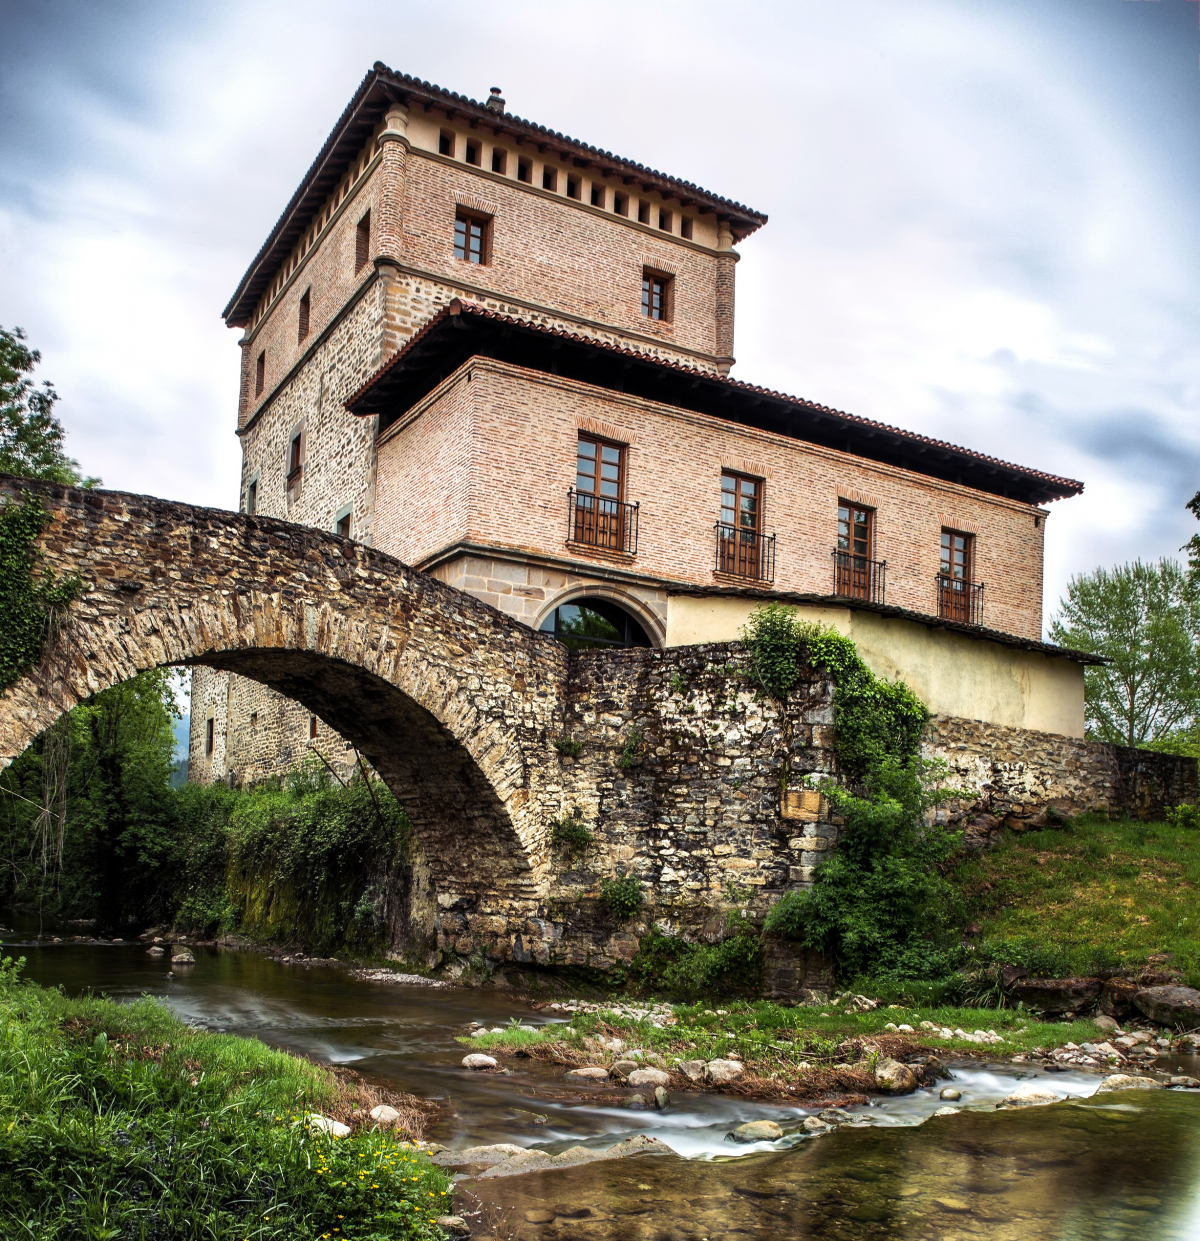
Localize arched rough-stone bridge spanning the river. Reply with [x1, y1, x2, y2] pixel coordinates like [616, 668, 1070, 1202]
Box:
[0, 479, 567, 933]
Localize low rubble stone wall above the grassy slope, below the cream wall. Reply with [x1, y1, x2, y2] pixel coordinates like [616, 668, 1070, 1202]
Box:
[922, 715, 1198, 848]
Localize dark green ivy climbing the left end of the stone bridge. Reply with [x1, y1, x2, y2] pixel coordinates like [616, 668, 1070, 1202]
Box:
[0, 496, 83, 692]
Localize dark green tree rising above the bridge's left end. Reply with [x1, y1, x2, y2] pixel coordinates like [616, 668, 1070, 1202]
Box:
[0, 328, 99, 486]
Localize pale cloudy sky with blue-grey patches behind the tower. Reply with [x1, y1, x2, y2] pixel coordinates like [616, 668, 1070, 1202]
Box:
[0, 0, 1200, 625]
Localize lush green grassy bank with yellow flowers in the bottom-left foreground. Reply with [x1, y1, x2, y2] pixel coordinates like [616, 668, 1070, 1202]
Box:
[0, 958, 450, 1241]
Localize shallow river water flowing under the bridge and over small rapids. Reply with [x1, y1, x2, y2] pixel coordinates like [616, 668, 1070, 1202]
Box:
[7, 933, 1200, 1241]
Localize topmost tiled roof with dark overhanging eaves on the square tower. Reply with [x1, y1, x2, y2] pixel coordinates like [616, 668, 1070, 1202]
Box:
[221, 61, 767, 326]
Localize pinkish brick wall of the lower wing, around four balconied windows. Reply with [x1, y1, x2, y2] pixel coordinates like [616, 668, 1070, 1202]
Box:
[377, 359, 1045, 639]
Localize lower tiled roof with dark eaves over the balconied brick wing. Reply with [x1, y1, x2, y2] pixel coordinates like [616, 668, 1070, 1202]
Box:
[346, 298, 1083, 503]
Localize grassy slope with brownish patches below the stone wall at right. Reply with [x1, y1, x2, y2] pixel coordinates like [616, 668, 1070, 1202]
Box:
[953, 818, 1200, 987]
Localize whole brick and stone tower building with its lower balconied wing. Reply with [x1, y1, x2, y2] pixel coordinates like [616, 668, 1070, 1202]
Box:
[191, 63, 1083, 781]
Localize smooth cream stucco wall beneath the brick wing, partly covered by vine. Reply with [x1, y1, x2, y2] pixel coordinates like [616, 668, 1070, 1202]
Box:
[666, 596, 1083, 737]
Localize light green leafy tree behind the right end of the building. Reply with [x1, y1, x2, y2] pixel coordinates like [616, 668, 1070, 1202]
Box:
[1050, 557, 1200, 746]
